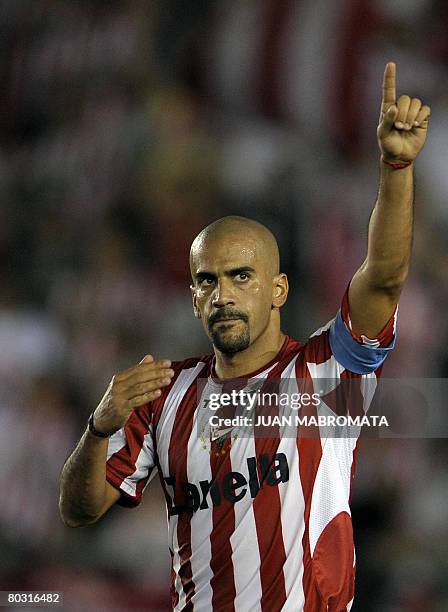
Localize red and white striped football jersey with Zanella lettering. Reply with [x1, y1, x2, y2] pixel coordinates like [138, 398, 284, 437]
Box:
[107, 293, 396, 612]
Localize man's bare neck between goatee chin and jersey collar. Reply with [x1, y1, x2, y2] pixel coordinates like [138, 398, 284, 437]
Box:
[215, 328, 285, 380]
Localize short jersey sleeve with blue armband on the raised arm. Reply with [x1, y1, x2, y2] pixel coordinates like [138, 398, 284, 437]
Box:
[329, 287, 398, 374]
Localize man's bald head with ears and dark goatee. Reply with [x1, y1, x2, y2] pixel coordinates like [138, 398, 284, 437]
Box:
[190, 216, 288, 354]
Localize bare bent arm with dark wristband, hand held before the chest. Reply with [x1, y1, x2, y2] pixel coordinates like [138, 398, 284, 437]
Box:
[59, 355, 174, 527]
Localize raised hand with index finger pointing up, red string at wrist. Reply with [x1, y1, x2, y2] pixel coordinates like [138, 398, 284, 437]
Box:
[377, 62, 431, 162]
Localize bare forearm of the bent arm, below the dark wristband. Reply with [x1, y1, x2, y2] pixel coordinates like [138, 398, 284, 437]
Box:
[59, 431, 108, 527]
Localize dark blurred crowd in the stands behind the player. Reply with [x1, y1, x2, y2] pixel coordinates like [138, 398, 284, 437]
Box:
[0, 0, 448, 612]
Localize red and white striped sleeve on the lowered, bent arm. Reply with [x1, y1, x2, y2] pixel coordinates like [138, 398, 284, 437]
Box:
[106, 405, 157, 508]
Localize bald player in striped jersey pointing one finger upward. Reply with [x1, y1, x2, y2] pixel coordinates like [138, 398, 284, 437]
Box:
[60, 63, 430, 612]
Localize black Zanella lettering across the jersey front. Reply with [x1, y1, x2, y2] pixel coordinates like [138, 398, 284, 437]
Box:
[163, 453, 289, 516]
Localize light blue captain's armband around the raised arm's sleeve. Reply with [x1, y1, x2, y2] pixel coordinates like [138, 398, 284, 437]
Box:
[329, 311, 396, 374]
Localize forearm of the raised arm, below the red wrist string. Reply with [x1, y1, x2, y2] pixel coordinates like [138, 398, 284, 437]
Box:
[364, 161, 414, 289]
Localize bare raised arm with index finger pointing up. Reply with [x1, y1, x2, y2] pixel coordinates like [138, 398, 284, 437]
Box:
[349, 62, 430, 338]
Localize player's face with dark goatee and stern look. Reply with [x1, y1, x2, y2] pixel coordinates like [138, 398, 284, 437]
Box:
[191, 234, 286, 354]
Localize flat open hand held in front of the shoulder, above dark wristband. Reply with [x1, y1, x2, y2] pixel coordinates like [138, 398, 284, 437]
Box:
[93, 355, 174, 435]
